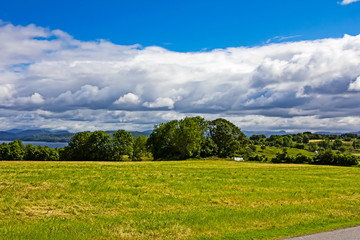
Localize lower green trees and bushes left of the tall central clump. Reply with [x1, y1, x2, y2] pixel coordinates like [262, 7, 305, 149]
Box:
[0, 130, 150, 161]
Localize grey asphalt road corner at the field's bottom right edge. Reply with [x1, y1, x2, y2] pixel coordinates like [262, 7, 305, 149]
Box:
[283, 226, 360, 240]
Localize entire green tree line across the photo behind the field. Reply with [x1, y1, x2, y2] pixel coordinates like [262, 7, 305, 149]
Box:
[0, 117, 360, 166]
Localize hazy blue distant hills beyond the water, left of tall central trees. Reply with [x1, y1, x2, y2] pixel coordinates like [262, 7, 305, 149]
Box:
[0, 129, 150, 142]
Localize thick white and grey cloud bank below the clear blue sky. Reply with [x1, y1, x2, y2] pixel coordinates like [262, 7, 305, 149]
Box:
[0, 22, 360, 131]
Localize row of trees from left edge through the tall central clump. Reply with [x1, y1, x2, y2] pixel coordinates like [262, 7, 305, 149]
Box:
[0, 117, 250, 161]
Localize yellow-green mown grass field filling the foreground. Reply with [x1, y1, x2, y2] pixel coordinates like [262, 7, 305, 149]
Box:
[0, 160, 360, 239]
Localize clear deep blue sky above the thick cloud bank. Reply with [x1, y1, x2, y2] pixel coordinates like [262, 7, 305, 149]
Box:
[0, 0, 360, 52]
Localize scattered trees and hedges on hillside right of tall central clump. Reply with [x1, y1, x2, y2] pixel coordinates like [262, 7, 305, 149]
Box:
[248, 132, 360, 166]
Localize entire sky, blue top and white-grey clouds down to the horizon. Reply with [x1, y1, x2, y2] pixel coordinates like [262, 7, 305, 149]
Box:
[0, 0, 360, 132]
